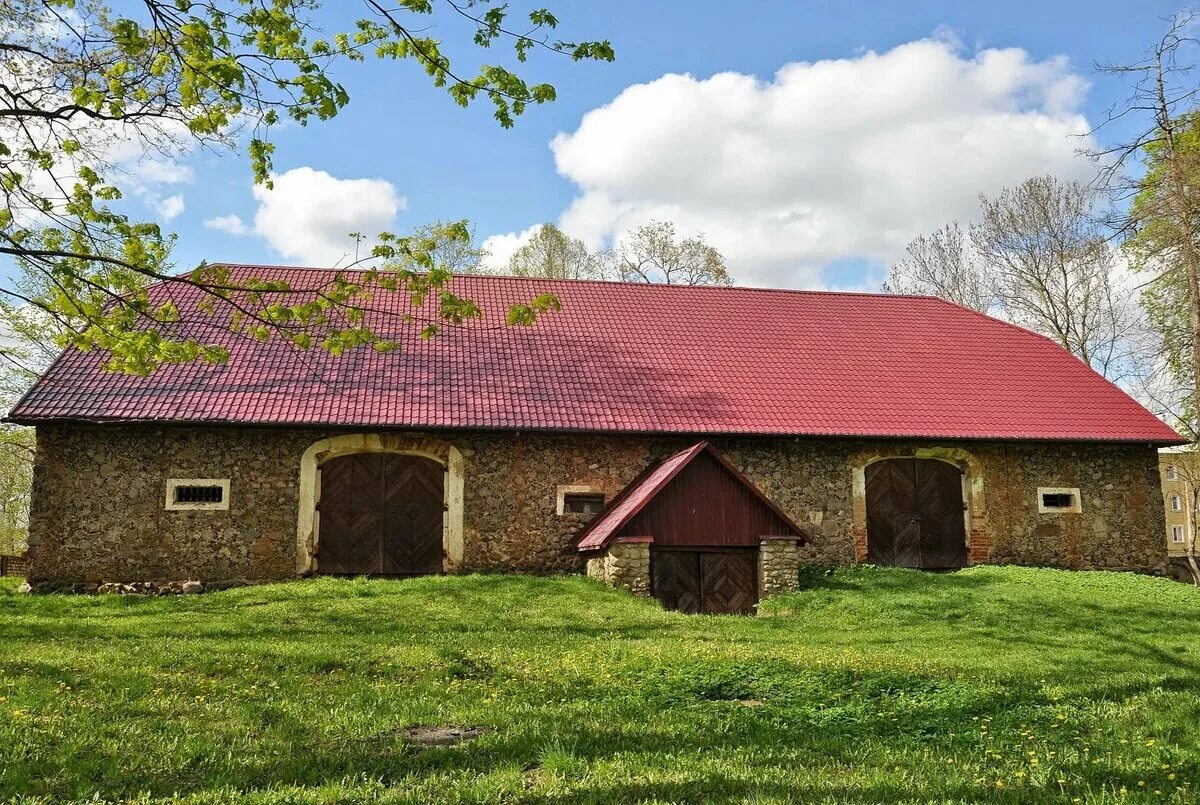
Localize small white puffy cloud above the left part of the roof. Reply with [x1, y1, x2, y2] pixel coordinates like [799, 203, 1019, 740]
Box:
[204, 167, 408, 268]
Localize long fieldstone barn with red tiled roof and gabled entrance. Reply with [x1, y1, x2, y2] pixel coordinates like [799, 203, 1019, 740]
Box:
[8, 266, 1180, 611]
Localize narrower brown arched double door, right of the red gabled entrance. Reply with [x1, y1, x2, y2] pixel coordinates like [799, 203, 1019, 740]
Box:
[866, 458, 967, 570]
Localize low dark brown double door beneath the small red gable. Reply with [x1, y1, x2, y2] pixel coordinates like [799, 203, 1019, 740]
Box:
[650, 549, 758, 614]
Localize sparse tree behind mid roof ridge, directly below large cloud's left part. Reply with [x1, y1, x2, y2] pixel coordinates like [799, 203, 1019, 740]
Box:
[608, 221, 733, 286]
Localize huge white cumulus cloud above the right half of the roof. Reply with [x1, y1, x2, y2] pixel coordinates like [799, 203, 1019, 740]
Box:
[549, 37, 1090, 287]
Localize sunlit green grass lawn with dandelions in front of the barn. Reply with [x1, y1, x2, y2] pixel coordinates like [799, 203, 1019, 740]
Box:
[0, 567, 1200, 803]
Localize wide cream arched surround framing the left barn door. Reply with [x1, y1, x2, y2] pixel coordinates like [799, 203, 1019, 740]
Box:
[296, 433, 463, 576]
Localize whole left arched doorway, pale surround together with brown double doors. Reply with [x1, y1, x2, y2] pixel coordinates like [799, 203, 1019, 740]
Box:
[296, 433, 463, 575]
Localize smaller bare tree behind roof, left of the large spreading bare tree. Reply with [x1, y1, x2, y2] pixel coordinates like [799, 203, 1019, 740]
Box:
[883, 221, 997, 313]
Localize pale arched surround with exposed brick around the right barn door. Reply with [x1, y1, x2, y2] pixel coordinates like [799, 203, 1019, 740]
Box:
[850, 447, 990, 564]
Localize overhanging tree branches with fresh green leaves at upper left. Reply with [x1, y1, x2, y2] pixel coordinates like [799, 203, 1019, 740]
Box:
[0, 0, 613, 372]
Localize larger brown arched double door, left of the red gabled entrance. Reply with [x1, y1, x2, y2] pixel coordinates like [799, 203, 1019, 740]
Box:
[317, 452, 445, 576]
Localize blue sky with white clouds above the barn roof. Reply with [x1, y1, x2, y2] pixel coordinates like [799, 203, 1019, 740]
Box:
[133, 0, 1178, 288]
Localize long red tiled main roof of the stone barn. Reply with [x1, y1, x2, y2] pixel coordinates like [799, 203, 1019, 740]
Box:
[10, 266, 1181, 444]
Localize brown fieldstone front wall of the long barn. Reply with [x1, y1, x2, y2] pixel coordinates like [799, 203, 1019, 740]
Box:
[29, 425, 1166, 583]
